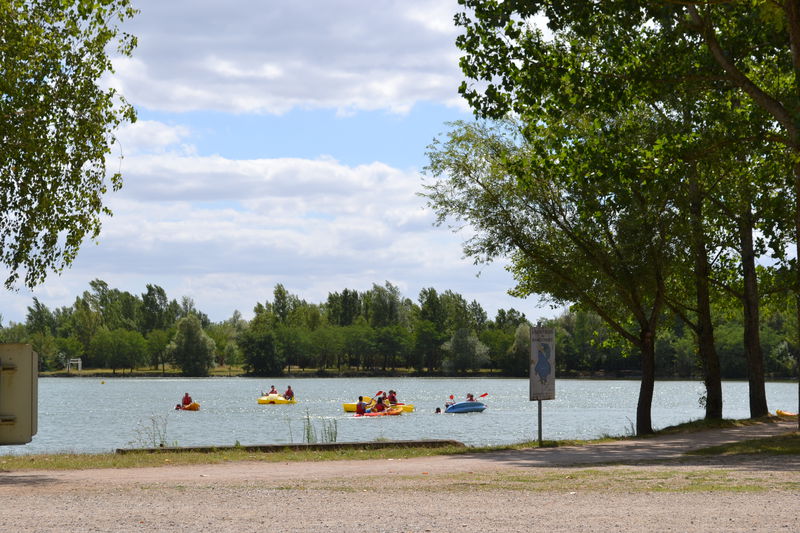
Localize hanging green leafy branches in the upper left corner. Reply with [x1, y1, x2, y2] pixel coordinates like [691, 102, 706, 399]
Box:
[0, 0, 136, 289]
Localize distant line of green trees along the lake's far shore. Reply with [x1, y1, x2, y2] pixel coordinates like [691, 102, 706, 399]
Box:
[0, 280, 797, 379]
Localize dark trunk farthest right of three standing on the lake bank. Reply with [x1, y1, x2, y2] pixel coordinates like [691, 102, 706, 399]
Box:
[739, 203, 769, 418]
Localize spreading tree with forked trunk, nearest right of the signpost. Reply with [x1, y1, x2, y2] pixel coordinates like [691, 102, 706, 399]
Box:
[425, 118, 675, 434]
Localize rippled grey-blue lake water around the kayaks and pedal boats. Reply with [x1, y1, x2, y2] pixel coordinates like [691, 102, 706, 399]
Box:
[0, 377, 797, 455]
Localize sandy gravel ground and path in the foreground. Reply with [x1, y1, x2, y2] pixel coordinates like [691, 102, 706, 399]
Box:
[0, 422, 800, 533]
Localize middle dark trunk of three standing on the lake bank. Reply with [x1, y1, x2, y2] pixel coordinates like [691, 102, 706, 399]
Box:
[689, 178, 722, 420]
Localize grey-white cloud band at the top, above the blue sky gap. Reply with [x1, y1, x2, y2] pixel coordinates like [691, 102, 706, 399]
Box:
[112, 0, 460, 114]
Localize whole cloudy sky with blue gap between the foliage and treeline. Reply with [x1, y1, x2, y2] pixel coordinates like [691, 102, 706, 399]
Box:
[0, 0, 554, 324]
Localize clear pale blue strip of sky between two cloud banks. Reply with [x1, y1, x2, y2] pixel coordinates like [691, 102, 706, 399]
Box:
[139, 102, 460, 170]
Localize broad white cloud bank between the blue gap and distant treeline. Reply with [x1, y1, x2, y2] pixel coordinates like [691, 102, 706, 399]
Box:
[0, 149, 548, 323]
